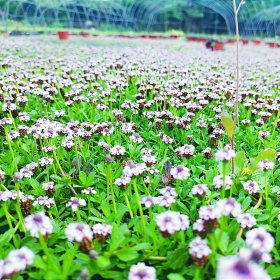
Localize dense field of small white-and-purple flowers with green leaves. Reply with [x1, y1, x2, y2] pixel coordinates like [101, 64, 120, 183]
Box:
[0, 37, 280, 280]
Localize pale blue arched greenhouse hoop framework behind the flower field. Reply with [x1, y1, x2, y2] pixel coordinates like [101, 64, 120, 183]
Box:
[0, 0, 280, 35]
